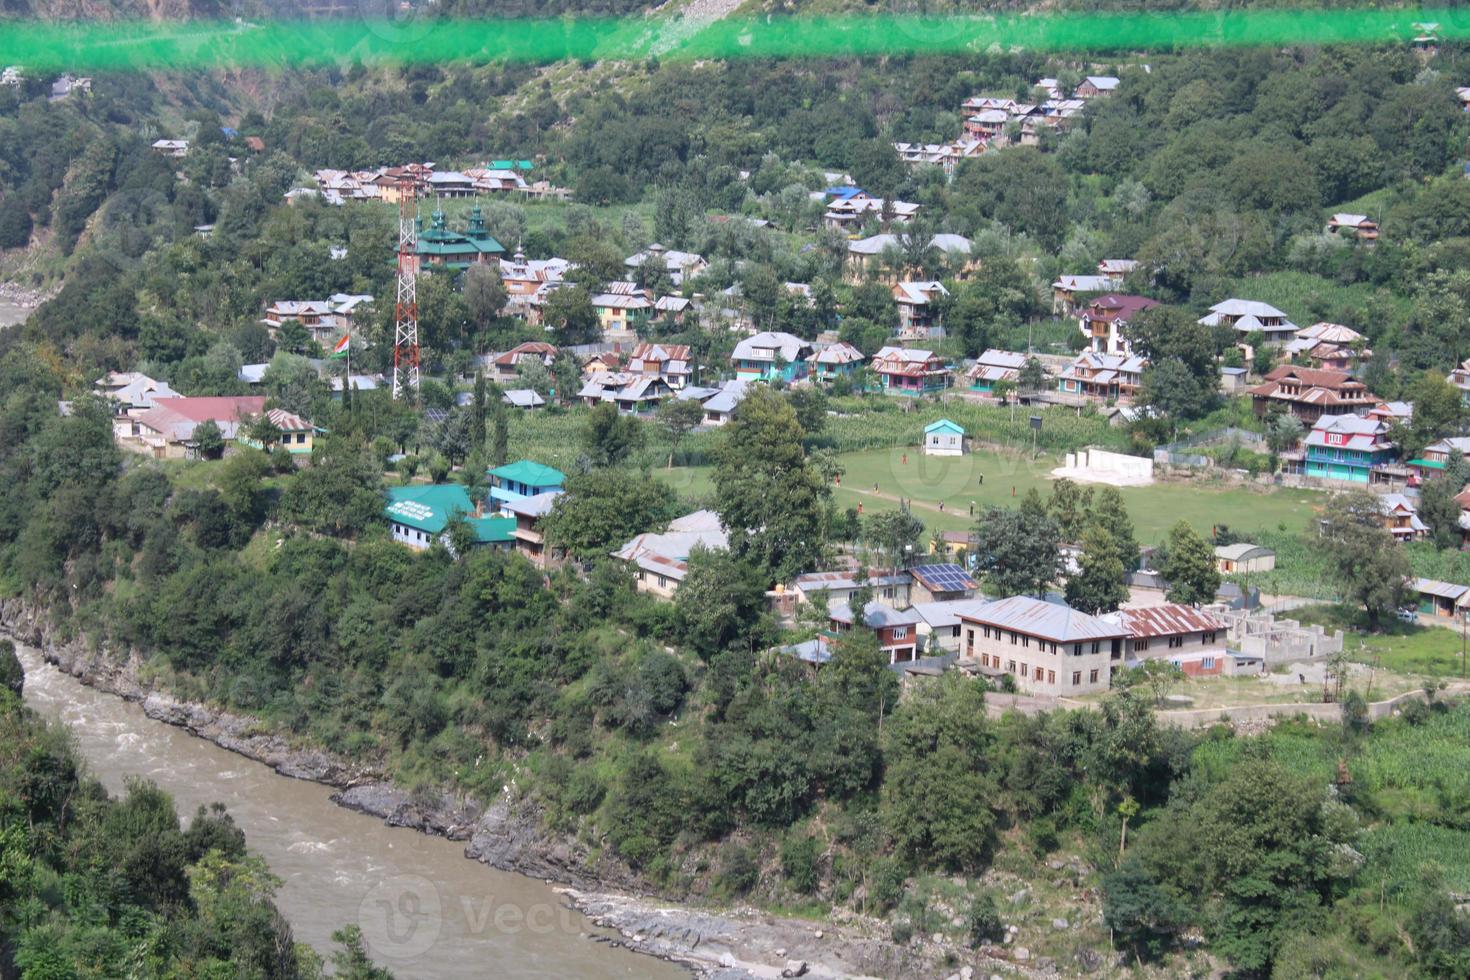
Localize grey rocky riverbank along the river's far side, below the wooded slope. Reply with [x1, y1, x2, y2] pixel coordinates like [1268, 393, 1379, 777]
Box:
[0, 599, 976, 980]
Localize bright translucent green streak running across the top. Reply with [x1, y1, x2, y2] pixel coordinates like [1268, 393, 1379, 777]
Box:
[0, 9, 1470, 71]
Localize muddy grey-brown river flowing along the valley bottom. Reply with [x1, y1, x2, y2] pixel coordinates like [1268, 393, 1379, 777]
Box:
[18, 648, 688, 980]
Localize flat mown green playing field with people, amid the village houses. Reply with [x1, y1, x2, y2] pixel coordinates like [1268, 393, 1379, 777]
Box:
[659, 450, 1323, 544]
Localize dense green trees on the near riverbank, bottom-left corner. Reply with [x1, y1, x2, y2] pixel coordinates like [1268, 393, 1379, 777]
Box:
[0, 696, 333, 980]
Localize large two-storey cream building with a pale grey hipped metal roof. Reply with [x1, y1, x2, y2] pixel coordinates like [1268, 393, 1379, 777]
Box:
[960, 595, 1129, 696]
